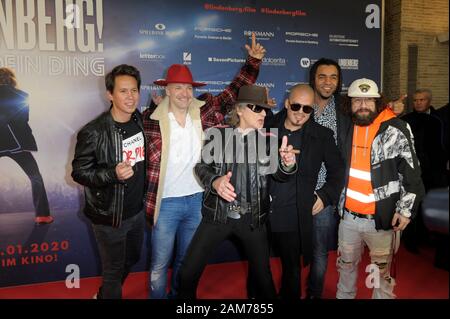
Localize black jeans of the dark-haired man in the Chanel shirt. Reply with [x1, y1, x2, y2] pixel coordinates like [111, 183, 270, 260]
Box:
[92, 211, 145, 299]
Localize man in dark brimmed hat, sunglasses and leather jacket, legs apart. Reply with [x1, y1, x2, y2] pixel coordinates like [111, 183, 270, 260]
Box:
[178, 85, 297, 299]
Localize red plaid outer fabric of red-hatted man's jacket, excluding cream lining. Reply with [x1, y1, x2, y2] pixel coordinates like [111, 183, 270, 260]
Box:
[143, 56, 261, 224]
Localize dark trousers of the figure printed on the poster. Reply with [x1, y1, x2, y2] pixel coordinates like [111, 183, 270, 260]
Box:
[0, 151, 50, 216]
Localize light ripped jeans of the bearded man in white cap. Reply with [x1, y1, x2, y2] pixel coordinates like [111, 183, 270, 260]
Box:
[336, 213, 395, 299]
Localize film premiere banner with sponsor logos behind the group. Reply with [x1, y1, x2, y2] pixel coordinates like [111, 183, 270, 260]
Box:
[0, 0, 382, 287]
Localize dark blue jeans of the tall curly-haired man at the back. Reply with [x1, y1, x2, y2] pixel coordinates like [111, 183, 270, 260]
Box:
[307, 206, 337, 298]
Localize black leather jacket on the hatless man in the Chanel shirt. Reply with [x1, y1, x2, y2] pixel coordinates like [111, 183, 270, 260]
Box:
[72, 111, 147, 227]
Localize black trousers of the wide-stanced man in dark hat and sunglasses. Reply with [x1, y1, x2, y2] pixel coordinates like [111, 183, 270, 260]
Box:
[178, 215, 276, 299]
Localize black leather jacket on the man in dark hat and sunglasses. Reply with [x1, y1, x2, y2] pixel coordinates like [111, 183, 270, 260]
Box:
[195, 128, 297, 228]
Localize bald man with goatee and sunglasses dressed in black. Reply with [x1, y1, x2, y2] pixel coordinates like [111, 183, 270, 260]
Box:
[266, 84, 344, 299]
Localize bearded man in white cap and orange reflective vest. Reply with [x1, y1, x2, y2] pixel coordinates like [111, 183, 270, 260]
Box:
[336, 78, 425, 299]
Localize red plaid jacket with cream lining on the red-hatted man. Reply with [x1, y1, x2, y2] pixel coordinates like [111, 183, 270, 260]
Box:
[143, 56, 261, 224]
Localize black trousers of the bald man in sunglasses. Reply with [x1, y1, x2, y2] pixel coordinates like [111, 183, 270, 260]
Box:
[272, 232, 301, 299]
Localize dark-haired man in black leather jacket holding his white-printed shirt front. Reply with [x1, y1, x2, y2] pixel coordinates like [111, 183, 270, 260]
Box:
[72, 64, 145, 299]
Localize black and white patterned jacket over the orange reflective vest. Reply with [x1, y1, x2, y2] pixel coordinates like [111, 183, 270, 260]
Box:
[338, 110, 425, 230]
